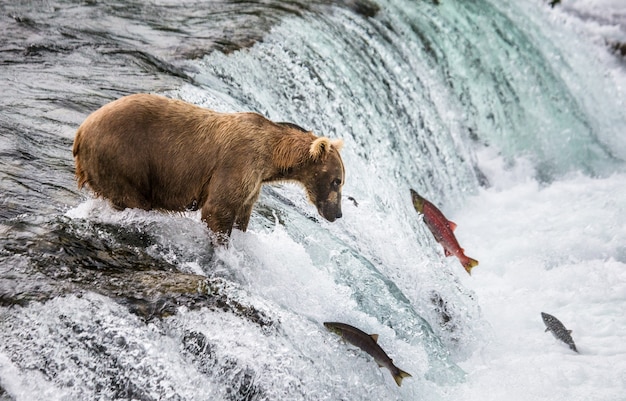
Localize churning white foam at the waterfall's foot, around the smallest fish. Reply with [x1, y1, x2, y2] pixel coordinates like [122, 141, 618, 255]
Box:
[449, 155, 626, 401]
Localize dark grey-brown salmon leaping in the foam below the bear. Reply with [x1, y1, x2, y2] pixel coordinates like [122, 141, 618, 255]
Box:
[324, 322, 411, 386]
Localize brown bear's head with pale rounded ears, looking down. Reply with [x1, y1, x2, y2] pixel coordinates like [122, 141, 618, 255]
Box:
[300, 137, 346, 222]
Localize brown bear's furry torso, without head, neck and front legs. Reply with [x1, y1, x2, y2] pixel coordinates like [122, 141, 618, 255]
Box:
[74, 94, 285, 210]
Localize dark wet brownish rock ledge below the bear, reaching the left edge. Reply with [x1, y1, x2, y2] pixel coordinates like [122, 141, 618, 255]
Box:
[0, 219, 276, 328]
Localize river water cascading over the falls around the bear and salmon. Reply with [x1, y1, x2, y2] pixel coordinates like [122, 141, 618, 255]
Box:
[0, 0, 626, 400]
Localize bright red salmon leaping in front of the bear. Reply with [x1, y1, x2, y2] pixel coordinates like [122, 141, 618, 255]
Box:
[411, 189, 478, 275]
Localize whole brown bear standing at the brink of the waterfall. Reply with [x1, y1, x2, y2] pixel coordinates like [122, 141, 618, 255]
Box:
[73, 94, 345, 242]
